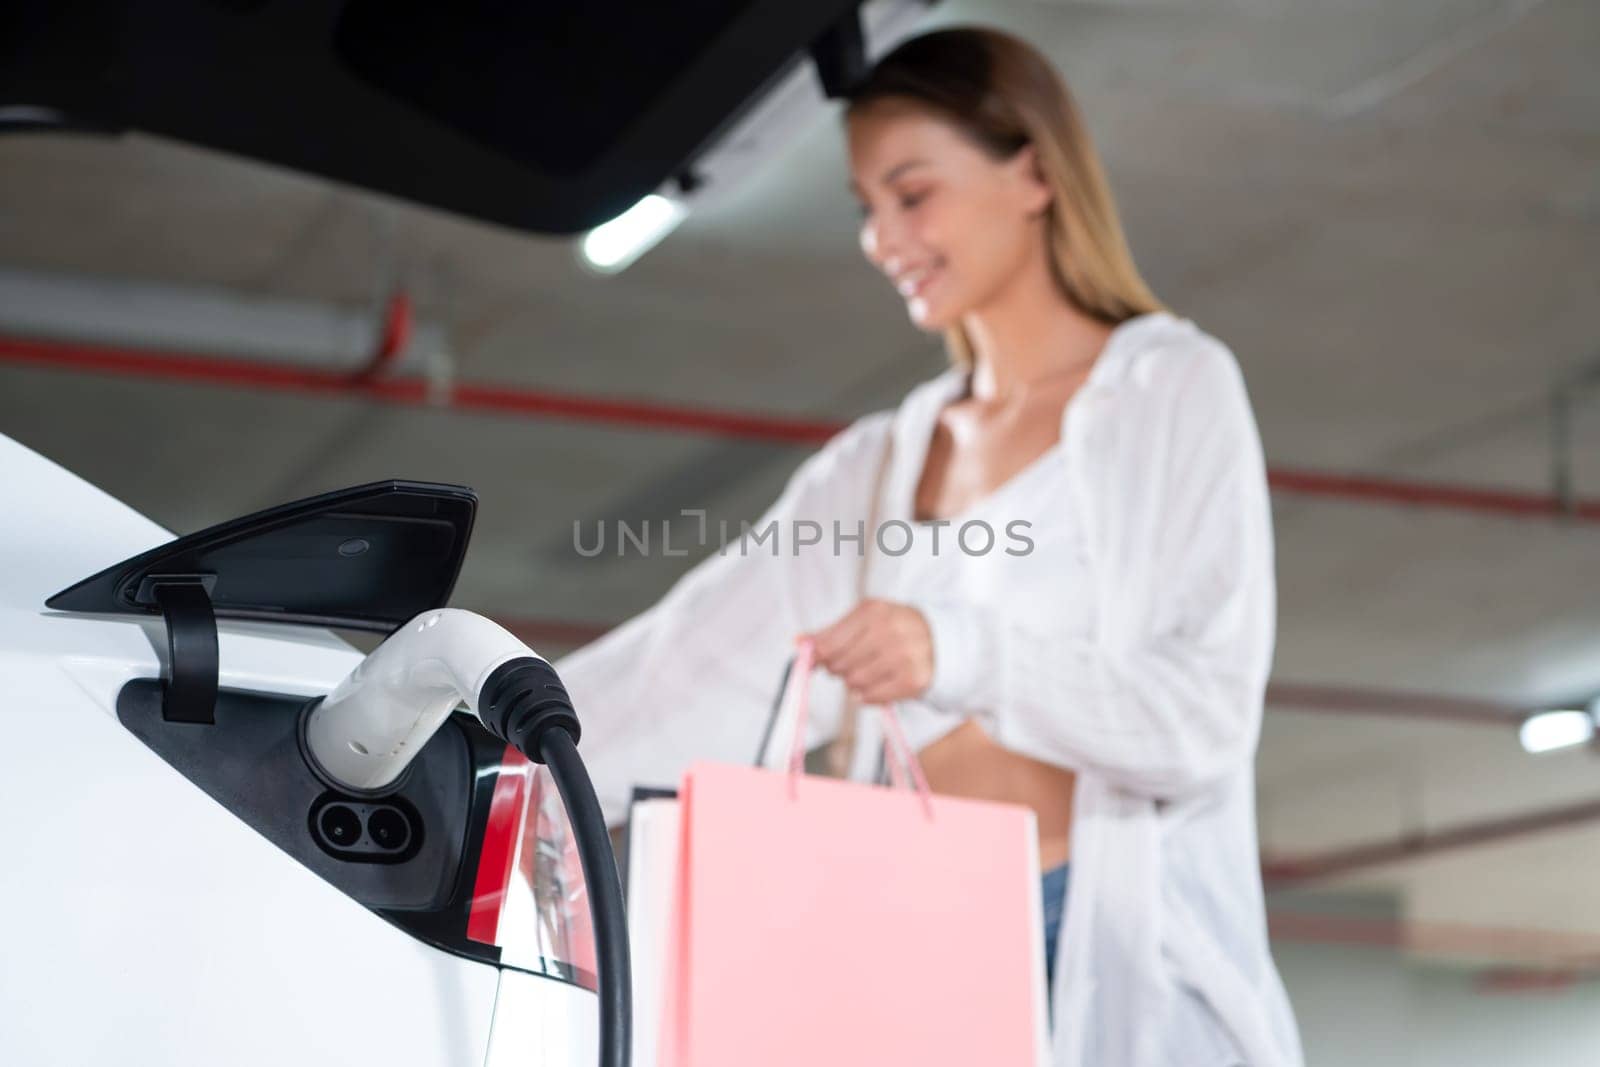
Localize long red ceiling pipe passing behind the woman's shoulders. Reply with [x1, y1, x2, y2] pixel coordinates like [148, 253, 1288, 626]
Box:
[0, 338, 1600, 522]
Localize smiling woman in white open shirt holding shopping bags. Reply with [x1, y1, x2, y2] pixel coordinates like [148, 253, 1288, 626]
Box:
[560, 29, 1301, 1067]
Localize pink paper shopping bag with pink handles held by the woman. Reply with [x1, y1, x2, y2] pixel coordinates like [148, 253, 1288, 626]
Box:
[659, 646, 1046, 1067]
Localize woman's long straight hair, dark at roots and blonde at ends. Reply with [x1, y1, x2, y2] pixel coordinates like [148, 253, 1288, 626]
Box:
[846, 27, 1162, 366]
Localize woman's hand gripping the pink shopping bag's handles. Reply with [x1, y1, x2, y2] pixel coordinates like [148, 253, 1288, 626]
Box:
[810, 600, 933, 704]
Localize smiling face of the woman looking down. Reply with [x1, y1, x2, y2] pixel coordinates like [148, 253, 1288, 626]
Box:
[850, 101, 1050, 331]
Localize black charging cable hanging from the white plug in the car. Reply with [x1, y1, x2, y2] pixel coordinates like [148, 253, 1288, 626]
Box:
[478, 656, 634, 1067]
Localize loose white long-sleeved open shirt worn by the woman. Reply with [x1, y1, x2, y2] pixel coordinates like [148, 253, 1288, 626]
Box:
[557, 314, 1302, 1067]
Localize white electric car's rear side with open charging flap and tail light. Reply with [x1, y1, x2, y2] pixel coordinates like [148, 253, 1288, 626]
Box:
[0, 437, 620, 1067]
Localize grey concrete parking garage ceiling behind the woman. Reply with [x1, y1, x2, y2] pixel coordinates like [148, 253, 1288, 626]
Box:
[0, 0, 1600, 966]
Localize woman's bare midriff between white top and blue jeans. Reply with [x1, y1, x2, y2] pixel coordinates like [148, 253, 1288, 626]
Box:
[917, 718, 1077, 870]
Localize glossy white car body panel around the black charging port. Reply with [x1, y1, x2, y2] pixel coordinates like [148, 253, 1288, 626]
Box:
[0, 437, 598, 1067]
